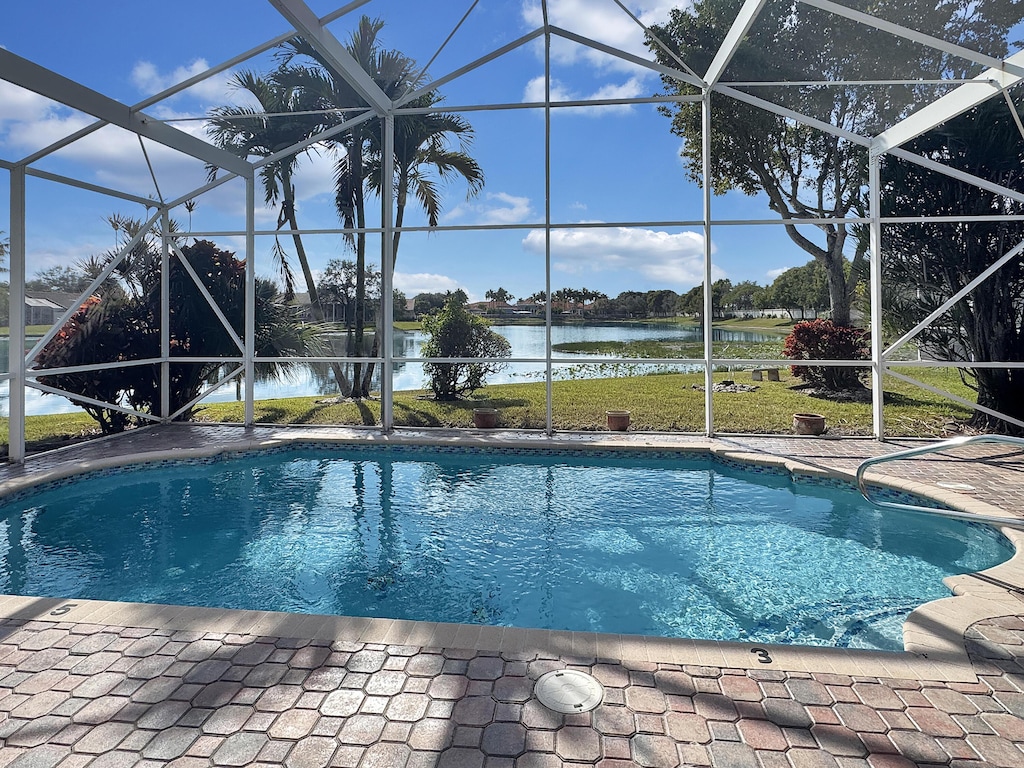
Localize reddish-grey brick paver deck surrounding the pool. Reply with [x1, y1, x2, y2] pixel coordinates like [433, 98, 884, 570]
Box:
[0, 426, 1024, 768]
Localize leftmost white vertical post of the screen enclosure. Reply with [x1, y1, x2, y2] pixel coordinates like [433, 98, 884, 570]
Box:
[7, 165, 26, 464]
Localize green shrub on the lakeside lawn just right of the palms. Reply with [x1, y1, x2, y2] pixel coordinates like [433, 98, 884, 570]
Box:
[423, 294, 512, 400]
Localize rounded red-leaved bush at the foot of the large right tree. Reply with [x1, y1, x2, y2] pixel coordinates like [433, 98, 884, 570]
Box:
[782, 319, 870, 389]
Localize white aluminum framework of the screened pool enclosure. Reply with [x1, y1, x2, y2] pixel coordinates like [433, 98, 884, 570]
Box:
[0, 0, 1024, 462]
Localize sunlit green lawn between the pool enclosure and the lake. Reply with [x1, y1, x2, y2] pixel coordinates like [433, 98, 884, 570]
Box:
[0, 369, 973, 452]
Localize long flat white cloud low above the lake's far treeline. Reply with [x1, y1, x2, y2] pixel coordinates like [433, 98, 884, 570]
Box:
[522, 226, 723, 289]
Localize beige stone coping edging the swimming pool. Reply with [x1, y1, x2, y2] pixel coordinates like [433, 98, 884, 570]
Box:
[0, 428, 1024, 682]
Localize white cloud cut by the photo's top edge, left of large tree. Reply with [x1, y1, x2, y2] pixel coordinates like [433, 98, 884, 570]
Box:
[522, 0, 677, 71]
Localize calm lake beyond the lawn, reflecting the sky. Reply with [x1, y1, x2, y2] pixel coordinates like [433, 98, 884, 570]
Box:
[0, 323, 779, 416]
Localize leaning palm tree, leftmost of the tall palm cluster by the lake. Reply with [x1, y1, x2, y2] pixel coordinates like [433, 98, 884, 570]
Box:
[207, 70, 350, 394]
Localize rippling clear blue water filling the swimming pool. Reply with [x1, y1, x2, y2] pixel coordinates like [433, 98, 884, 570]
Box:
[0, 447, 1012, 649]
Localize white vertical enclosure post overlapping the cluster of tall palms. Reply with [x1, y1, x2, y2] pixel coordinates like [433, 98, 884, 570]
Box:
[376, 113, 394, 432]
